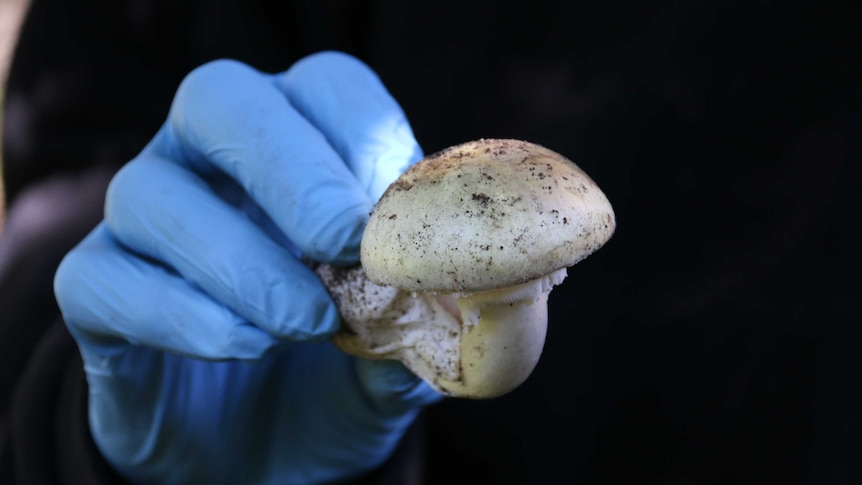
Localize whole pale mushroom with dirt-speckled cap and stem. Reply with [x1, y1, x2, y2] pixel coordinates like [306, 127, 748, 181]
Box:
[317, 139, 616, 398]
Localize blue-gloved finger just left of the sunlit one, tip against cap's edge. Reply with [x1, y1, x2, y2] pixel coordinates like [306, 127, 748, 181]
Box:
[145, 61, 372, 264]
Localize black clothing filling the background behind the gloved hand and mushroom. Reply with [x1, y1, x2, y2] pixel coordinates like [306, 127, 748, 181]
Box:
[0, 0, 862, 484]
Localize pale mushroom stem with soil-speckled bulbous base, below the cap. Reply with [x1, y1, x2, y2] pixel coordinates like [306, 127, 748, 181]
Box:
[317, 265, 566, 398]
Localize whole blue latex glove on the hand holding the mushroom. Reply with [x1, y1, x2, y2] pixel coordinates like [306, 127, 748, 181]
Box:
[55, 53, 440, 484]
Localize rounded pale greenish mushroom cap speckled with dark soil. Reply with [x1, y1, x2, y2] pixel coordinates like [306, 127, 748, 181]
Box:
[361, 139, 616, 293]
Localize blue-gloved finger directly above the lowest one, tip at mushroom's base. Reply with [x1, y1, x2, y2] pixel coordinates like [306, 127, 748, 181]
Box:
[105, 155, 339, 341]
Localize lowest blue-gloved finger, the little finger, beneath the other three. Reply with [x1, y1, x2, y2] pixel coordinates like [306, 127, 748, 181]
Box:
[54, 224, 279, 360]
